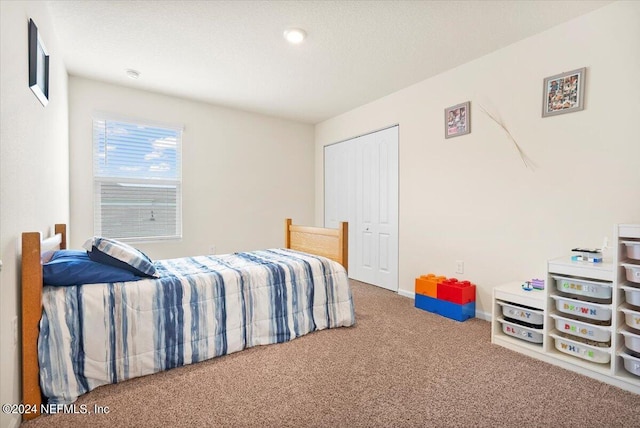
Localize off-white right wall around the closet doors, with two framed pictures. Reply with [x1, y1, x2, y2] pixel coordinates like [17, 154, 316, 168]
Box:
[316, 2, 640, 314]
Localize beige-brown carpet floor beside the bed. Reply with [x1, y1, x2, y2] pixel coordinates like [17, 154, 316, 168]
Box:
[22, 281, 640, 428]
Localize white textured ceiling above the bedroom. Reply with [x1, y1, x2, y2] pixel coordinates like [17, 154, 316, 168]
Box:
[48, 0, 610, 123]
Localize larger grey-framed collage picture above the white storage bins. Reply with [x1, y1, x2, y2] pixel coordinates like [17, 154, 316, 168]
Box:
[542, 67, 587, 117]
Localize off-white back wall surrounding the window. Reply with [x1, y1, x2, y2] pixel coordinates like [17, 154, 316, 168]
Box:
[69, 76, 314, 259]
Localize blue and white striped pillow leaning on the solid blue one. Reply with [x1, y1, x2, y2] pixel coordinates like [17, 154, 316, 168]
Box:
[83, 236, 159, 278]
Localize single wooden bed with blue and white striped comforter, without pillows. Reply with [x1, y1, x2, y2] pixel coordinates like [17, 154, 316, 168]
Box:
[22, 219, 355, 419]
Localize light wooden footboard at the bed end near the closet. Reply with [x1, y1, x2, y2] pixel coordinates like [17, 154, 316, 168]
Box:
[284, 218, 349, 270]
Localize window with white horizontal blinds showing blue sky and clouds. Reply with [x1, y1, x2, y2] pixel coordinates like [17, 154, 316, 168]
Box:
[93, 119, 182, 241]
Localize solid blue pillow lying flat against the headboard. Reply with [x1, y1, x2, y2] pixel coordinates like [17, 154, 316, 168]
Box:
[42, 250, 141, 285]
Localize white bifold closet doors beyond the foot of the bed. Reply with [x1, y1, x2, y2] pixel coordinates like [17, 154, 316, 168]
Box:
[324, 126, 398, 291]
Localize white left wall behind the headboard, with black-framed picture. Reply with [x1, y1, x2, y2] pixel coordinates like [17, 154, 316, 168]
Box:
[0, 1, 69, 427]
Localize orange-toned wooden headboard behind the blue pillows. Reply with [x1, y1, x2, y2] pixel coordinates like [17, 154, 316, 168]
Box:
[22, 224, 67, 419]
